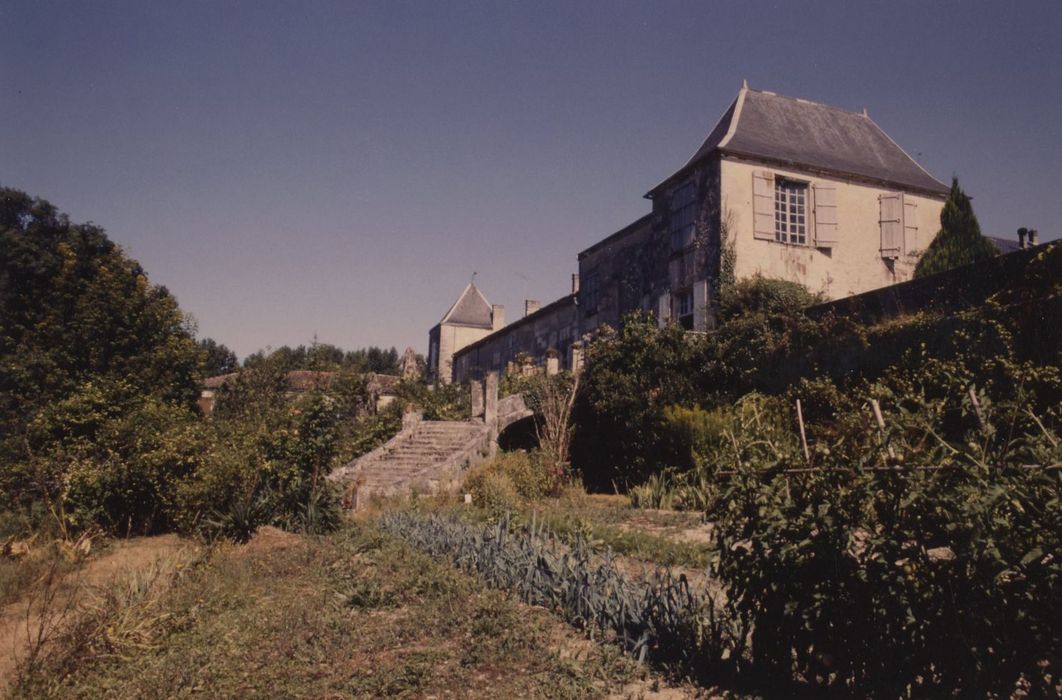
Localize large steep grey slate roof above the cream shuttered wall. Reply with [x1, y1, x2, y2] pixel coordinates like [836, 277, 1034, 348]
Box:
[650, 87, 948, 195]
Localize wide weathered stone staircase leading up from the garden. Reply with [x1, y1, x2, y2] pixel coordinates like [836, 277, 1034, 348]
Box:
[328, 414, 492, 509]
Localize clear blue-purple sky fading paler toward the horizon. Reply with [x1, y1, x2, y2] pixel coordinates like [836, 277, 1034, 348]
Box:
[0, 0, 1062, 357]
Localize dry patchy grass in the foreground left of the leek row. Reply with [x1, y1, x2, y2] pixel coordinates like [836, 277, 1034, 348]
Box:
[13, 524, 687, 698]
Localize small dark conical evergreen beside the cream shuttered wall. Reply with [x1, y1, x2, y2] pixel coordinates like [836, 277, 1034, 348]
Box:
[914, 177, 996, 278]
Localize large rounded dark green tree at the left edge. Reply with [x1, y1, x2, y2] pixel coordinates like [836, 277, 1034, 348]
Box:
[0, 188, 202, 530]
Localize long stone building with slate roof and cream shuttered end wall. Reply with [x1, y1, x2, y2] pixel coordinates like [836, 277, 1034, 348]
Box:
[443, 86, 948, 380]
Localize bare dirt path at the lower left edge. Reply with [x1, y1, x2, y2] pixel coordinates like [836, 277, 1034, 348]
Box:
[0, 534, 195, 690]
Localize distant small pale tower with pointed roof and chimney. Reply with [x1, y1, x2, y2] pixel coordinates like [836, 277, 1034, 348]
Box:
[428, 283, 506, 383]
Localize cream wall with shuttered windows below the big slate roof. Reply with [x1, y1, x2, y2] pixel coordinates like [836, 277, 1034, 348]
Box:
[720, 159, 944, 300]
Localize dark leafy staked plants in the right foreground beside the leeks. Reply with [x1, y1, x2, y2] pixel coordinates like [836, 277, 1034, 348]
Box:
[708, 364, 1062, 697]
